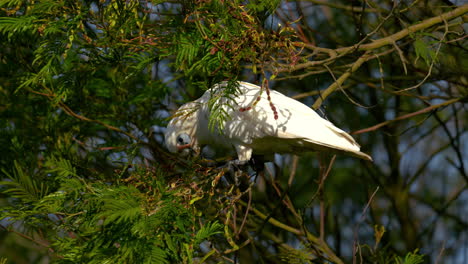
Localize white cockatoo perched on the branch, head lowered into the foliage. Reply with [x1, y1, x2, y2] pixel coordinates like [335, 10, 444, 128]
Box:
[165, 82, 372, 164]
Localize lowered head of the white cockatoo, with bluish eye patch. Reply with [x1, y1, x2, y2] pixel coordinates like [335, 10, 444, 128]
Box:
[164, 102, 199, 156]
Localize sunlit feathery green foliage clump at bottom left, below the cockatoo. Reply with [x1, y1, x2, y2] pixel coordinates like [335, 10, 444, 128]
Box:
[2, 159, 223, 263]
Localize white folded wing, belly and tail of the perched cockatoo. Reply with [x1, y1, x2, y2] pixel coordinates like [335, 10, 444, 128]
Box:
[219, 82, 372, 160]
